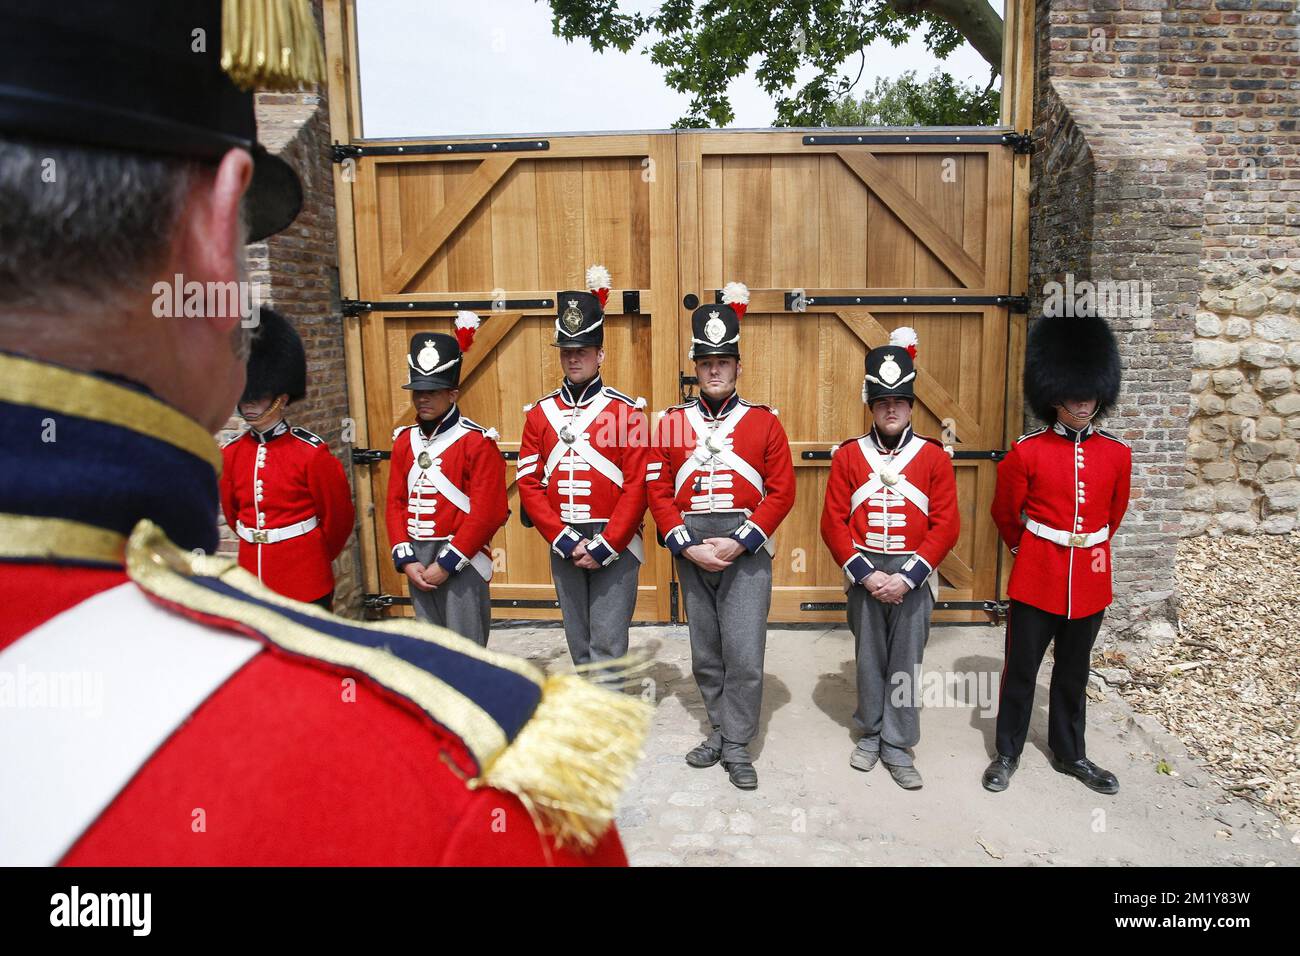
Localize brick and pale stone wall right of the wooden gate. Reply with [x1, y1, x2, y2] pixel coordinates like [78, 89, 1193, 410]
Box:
[1030, 0, 1300, 627]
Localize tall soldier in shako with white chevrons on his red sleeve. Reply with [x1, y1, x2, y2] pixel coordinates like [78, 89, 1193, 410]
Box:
[516, 265, 650, 665]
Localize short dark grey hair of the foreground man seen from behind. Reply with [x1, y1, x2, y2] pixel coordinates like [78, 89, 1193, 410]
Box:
[0, 137, 198, 312]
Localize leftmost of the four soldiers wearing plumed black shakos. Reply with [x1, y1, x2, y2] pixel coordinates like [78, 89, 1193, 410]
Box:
[387, 321, 510, 646]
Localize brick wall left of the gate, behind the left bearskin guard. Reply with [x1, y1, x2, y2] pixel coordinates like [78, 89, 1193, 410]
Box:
[221, 70, 363, 617]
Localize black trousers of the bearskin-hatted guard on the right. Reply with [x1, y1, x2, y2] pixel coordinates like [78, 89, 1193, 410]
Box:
[997, 601, 1105, 761]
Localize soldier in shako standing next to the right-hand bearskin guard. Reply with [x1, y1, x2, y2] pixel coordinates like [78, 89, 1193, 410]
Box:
[822, 326, 961, 790]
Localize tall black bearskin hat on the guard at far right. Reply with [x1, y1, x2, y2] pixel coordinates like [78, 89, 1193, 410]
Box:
[1024, 316, 1122, 424]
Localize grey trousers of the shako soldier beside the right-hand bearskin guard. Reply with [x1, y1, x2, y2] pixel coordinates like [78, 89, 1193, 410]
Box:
[848, 554, 935, 766]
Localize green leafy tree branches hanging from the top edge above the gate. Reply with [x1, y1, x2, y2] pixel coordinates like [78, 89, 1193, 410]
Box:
[546, 0, 1002, 127]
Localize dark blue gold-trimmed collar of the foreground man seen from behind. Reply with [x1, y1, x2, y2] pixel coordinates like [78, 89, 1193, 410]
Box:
[0, 352, 221, 563]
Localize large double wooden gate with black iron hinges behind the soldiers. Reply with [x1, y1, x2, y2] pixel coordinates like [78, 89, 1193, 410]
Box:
[346, 130, 1013, 622]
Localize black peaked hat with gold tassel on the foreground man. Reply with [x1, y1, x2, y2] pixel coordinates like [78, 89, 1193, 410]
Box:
[0, 0, 324, 242]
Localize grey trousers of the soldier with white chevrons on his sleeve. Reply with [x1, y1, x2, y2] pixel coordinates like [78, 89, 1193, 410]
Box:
[551, 522, 641, 665]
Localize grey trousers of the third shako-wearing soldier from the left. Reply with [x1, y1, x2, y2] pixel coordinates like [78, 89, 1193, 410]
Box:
[677, 512, 772, 763]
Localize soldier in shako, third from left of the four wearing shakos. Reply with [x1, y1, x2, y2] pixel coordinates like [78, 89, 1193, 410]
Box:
[646, 282, 794, 790]
